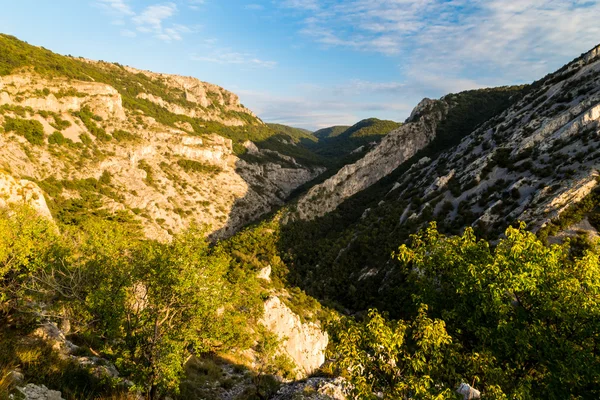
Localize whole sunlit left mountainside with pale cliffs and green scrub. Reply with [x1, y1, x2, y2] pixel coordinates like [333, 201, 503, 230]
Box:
[0, 35, 323, 239]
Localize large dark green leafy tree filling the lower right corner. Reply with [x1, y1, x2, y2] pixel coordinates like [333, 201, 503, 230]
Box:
[397, 225, 600, 399]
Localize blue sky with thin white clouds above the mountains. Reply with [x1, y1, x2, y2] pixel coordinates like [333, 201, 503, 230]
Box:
[0, 0, 600, 129]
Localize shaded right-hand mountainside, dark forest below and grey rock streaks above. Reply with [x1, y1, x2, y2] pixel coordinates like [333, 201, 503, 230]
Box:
[282, 43, 600, 312]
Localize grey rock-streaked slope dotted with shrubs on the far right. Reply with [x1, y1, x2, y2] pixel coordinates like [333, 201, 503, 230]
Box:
[383, 43, 600, 234]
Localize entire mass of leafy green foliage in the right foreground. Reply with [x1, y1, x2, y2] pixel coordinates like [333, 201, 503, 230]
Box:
[332, 225, 600, 399]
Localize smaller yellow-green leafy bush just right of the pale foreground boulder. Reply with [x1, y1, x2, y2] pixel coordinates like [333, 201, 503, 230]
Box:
[330, 306, 455, 400]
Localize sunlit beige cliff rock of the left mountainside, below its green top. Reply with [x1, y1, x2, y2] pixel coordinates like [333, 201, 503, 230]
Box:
[0, 70, 322, 239]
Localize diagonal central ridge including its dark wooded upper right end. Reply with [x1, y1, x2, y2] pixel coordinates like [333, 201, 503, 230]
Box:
[294, 88, 518, 219]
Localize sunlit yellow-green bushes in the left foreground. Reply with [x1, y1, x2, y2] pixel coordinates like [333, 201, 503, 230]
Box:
[0, 206, 286, 399]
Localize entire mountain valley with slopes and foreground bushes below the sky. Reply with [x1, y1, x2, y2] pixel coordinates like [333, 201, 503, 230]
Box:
[0, 34, 600, 400]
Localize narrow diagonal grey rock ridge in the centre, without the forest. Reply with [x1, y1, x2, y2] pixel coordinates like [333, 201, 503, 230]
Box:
[290, 99, 448, 220]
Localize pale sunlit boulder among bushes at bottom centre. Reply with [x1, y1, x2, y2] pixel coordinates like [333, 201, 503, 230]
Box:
[261, 297, 329, 377]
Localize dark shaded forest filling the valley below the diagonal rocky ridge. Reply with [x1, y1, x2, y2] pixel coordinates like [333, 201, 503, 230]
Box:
[281, 87, 520, 317]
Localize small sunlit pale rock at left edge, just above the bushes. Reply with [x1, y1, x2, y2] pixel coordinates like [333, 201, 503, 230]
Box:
[0, 172, 52, 219]
